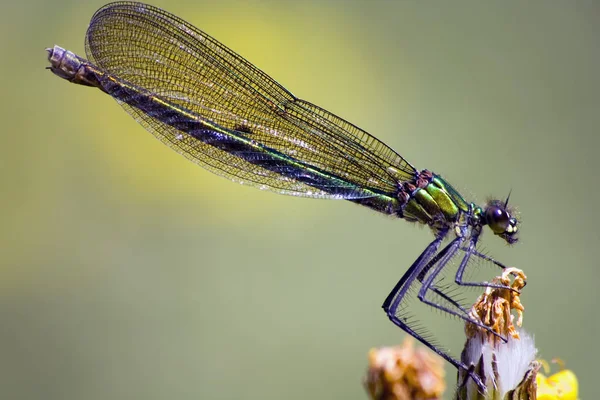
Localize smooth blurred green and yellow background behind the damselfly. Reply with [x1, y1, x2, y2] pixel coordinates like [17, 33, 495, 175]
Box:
[0, 0, 600, 400]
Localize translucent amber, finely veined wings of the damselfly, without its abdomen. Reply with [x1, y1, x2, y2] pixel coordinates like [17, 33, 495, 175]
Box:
[86, 2, 415, 198]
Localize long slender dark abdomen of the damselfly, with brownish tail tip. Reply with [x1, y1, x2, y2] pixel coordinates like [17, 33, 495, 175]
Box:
[47, 46, 400, 215]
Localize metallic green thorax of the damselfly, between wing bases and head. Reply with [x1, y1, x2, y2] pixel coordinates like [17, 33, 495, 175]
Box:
[403, 175, 469, 225]
